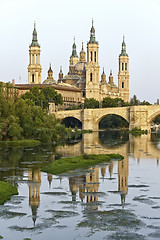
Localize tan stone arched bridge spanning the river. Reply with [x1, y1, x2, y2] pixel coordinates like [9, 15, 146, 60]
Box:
[53, 105, 160, 131]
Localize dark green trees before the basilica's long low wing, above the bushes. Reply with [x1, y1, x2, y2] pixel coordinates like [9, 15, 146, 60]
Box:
[21, 86, 63, 109]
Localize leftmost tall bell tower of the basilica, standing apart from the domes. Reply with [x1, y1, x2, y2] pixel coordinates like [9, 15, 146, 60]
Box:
[28, 23, 42, 84]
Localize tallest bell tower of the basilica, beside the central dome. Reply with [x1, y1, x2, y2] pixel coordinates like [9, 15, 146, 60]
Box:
[85, 20, 100, 100]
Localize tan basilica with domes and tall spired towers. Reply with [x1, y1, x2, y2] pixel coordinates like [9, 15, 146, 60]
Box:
[16, 20, 129, 105]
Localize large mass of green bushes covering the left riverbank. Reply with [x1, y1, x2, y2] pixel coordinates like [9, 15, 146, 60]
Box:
[0, 91, 66, 143]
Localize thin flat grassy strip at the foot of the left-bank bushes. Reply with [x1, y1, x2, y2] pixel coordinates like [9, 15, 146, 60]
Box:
[0, 139, 41, 147]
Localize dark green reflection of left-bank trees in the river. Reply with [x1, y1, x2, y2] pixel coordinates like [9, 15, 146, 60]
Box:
[0, 145, 55, 183]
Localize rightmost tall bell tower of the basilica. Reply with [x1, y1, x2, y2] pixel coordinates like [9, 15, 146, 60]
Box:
[118, 36, 129, 102]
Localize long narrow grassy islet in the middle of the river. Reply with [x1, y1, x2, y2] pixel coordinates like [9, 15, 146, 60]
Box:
[42, 154, 123, 175]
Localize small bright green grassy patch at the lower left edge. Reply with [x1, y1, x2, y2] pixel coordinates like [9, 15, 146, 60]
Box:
[0, 181, 18, 205]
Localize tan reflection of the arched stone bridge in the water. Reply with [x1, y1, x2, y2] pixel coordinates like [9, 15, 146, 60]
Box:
[56, 132, 160, 159]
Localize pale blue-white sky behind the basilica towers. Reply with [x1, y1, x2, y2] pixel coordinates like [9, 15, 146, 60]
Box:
[0, 0, 160, 103]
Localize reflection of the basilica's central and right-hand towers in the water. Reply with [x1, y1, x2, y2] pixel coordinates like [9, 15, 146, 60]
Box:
[69, 158, 128, 208]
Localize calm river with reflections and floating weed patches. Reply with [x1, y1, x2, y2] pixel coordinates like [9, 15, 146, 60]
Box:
[0, 131, 160, 240]
